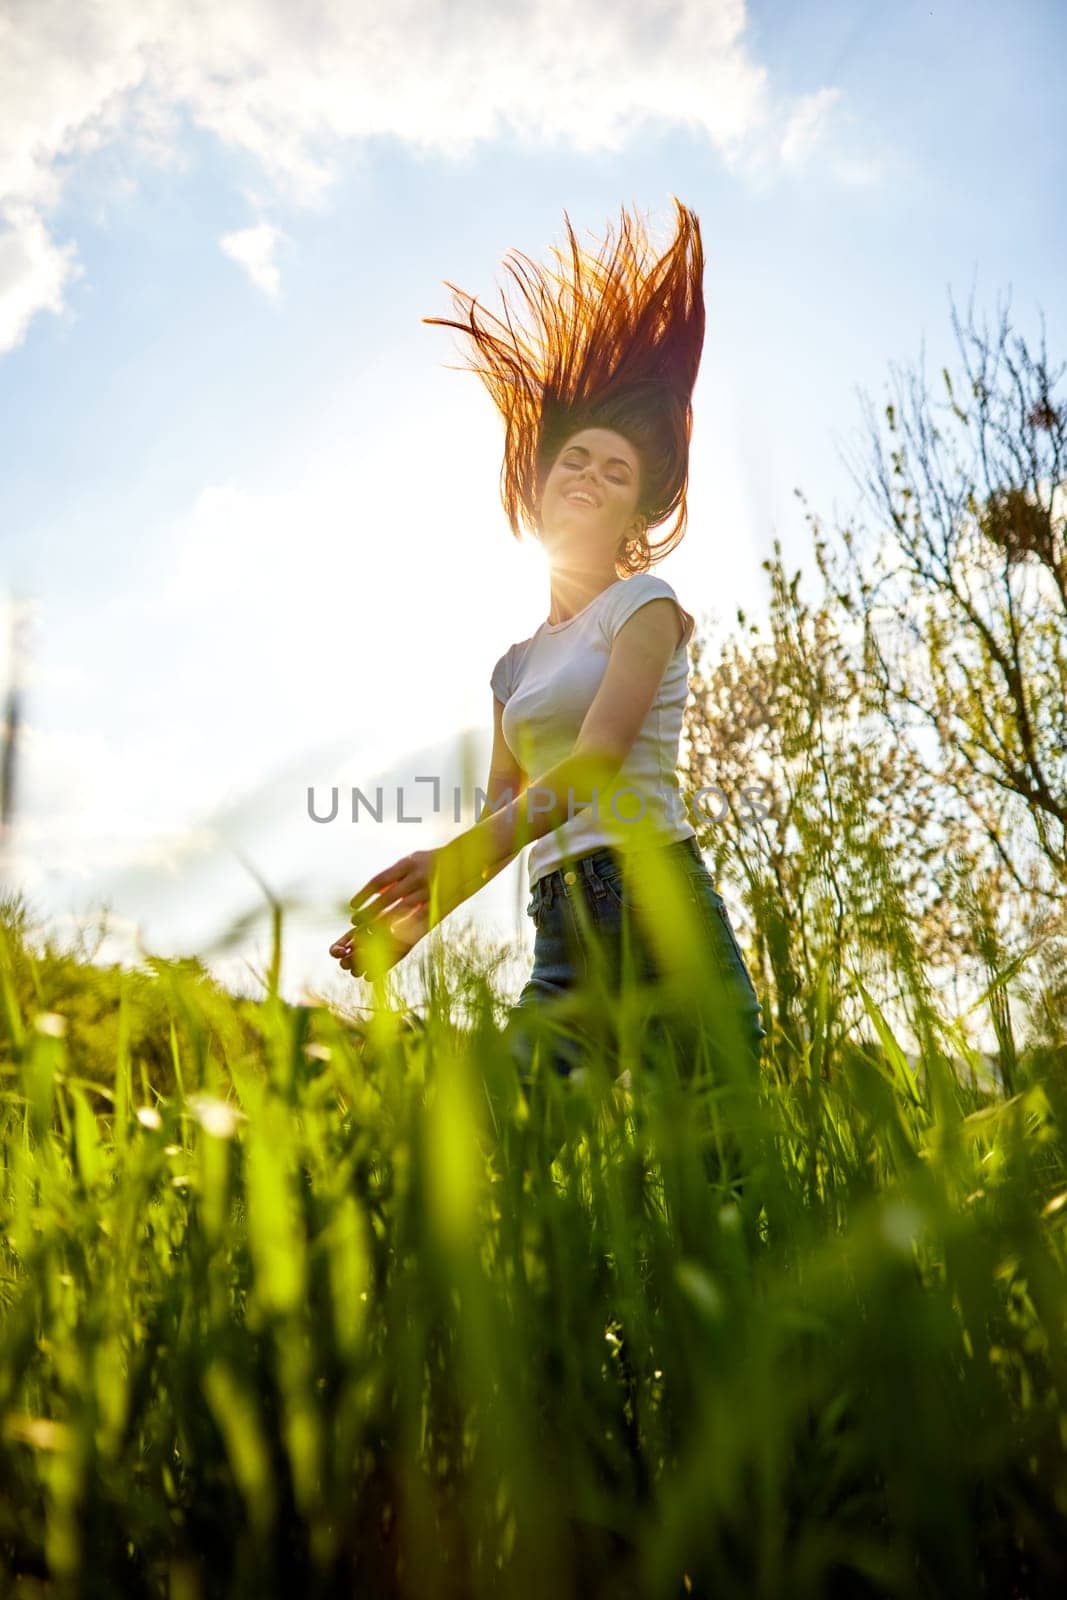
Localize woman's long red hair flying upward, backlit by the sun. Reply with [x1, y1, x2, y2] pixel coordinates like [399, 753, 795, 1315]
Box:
[422, 195, 704, 573]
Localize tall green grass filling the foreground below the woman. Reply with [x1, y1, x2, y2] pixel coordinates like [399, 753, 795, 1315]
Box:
[0, 898, 1067, 1600]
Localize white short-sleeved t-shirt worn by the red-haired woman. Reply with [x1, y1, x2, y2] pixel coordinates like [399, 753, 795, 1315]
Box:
[490, 573, 696, 888]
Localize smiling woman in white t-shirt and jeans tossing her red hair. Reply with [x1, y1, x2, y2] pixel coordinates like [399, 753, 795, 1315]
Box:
[331, 198, 765, 1100]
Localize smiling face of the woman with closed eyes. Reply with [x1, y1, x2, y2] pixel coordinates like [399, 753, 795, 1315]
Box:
[541, 427, 641, 565]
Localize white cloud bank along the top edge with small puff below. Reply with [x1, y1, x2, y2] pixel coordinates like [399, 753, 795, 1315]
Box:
[0, 0, 857, 350]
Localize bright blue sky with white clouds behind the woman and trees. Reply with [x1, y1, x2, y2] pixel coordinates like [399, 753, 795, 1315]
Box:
[0, 0, 1067, 998]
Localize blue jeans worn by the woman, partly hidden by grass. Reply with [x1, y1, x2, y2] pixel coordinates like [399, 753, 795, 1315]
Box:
[506, 837, 766, 1088]
